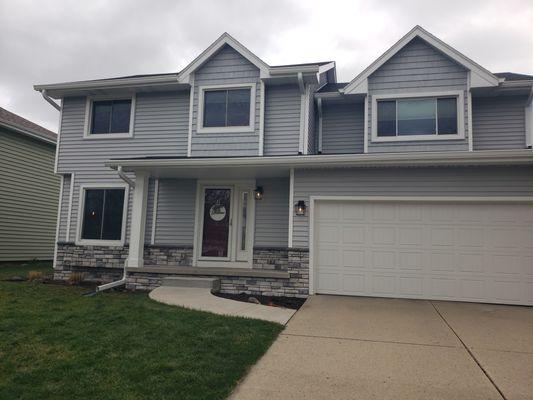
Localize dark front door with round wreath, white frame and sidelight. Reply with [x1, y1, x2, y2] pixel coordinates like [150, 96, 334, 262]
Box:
[195, 183, 255, 267]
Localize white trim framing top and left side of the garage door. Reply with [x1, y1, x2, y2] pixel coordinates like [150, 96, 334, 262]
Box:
[308, 196, 533, 295]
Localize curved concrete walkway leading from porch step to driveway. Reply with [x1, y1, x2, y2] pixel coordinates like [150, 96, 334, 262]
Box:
[149, 286, 296, 325]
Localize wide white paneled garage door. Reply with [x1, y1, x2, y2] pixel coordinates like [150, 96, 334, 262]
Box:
[313, 201, 533, 305]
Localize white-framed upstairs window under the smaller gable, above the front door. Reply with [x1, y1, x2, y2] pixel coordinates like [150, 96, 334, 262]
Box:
[198, 85, 255, 132]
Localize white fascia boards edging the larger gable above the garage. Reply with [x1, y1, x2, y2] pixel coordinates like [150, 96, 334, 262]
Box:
[341, 25, 499, 94]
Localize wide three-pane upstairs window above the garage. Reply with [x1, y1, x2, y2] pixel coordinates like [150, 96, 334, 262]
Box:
[377, 97, 459, 139]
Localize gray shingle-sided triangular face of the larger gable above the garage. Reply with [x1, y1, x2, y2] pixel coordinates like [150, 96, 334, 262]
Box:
[368, 37, 468, 90]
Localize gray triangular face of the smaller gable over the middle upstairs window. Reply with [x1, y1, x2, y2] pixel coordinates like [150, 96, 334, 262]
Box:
[195, 44, 259, 81]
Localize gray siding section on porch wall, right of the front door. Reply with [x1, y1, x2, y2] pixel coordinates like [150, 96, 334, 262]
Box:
[254, 178, 289, 247]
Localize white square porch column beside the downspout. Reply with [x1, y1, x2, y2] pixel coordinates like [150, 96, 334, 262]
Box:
[126, 172, 149, 267]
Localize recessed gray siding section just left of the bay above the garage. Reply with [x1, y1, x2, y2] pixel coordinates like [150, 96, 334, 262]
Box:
[322, 103, 364, 154]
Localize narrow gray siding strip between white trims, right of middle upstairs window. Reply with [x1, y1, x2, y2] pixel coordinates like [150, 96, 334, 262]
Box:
[263, 85, 301, 156]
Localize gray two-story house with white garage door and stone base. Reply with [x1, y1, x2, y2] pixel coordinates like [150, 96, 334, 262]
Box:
[35, 27, 533, 305]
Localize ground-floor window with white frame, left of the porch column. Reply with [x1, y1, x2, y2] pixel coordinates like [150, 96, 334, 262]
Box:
[79, 187, 126, 243]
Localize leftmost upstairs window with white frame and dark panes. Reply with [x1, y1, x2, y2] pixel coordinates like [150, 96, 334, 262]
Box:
[85, 98, 134, 138]
